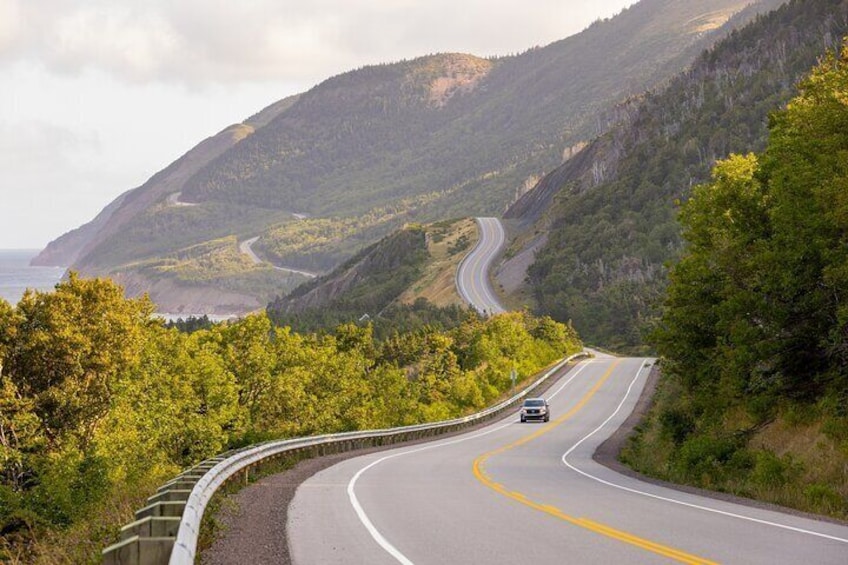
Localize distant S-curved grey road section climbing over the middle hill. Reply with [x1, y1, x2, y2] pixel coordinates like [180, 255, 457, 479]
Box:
[456, 218, 506, 315]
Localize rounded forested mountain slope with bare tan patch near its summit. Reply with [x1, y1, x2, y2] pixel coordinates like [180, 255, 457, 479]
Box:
[179, 0, 760, 223]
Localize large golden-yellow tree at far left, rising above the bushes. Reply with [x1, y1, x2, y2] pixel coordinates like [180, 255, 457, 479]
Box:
[4, 273, 153, 448]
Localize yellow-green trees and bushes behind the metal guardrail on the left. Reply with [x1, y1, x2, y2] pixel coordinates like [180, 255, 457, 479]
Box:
[0, 275, 580, 563]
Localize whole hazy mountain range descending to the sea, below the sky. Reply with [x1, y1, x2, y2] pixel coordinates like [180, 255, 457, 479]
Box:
[37, 0, 779, 312]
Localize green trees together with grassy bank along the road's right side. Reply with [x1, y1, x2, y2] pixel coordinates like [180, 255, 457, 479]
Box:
[629, 43, 848, 518]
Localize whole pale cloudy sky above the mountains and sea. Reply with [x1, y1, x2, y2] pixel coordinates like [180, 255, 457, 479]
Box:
[0, 0, 634, 249]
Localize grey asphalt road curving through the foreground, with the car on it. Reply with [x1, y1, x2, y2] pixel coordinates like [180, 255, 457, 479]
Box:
[287, 358, 848, 565]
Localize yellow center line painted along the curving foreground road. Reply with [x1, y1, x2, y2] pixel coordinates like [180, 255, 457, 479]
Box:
[473, 361, 716, 565]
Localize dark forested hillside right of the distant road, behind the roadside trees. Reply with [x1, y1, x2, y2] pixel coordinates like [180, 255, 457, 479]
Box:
[507, 0, 848, 350]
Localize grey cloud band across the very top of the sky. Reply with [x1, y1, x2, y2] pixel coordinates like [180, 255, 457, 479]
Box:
[0, 0, 632, 86]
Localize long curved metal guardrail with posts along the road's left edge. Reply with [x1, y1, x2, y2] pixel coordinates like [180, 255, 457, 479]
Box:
[103, 351, 589, 565]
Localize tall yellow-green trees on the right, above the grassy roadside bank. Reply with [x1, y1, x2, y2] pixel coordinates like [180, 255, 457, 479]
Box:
[653, 40, 848, 422]
